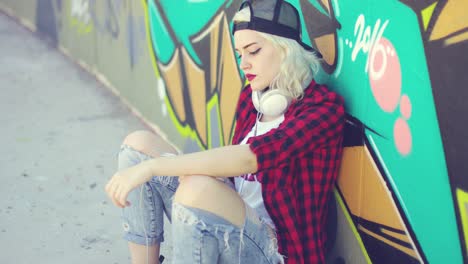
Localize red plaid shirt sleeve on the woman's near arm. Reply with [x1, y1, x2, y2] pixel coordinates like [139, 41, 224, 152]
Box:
[248, 87, 344, 171]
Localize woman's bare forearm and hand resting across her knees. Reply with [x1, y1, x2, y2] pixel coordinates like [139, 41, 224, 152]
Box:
[105, 145, 257, 207]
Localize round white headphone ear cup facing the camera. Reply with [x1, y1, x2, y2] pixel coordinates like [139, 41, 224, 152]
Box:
[259, 90, 291, 116]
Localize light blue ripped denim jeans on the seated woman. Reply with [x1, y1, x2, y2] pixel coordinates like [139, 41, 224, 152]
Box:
[118, 145, 284, 264]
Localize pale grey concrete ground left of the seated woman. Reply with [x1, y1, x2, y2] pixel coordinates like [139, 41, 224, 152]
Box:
[0, 13, 171, 264]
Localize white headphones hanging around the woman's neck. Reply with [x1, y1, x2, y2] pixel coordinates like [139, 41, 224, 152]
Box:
[252, 89, 292, 116]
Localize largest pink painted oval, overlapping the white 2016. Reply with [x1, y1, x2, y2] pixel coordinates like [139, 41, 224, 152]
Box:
[369, 38, 401, 112]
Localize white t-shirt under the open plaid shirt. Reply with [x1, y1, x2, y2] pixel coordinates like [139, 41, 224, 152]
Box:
[234, 115, 284, 228]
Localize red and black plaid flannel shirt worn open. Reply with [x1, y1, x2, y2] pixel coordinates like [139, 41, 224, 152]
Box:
[233, 81, 345, 264]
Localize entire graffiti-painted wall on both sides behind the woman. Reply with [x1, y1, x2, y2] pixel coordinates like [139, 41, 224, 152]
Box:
[0, 0, 468, 263]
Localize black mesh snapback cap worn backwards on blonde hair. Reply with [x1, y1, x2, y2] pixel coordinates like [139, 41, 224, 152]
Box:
[232, 0, 322, 58]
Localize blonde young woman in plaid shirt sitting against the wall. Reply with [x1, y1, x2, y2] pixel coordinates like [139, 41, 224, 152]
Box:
[106, 0, 344, 263]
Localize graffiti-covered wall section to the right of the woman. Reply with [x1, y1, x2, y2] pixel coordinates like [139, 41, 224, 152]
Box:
[306, 1, 468, 263]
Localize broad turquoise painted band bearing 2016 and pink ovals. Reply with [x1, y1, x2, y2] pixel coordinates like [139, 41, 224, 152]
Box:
[303, 0, 462, 263]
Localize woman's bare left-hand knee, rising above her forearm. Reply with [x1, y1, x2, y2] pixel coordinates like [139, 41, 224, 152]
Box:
[122, 130, 177, 157]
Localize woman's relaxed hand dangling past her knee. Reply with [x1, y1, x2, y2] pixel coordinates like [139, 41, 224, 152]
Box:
[105, 162, 152, 208]
